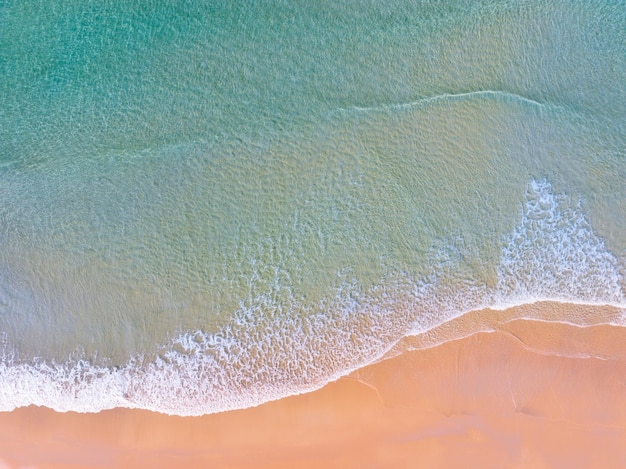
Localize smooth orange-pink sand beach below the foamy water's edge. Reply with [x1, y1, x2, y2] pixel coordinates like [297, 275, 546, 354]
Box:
[0, 304, 626, 468]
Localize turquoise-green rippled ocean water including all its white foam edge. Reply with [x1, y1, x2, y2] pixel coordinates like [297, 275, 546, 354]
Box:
[0, 0, 626, 415]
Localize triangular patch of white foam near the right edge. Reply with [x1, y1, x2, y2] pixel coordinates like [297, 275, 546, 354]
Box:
[494, 181, 625, 307]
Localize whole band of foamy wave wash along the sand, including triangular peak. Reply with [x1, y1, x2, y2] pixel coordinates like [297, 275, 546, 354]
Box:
[0, 181, 626, 415]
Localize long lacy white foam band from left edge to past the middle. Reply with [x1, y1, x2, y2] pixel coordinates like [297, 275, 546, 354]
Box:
[0, 276, 420, 415]
